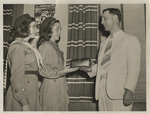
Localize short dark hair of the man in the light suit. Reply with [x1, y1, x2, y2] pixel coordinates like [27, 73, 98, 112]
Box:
[103, 8, 121, 22]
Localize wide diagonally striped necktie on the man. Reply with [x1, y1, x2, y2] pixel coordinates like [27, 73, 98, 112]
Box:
[101, 37, 112, 69]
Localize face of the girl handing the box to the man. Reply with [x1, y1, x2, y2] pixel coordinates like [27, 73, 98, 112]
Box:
[51, 22, 61, 42]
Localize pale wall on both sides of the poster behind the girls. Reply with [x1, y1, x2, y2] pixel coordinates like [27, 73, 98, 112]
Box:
[24, 4, 68, 65]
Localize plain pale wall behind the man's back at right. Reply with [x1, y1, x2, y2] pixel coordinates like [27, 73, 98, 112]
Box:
[123, 4, 146, 102]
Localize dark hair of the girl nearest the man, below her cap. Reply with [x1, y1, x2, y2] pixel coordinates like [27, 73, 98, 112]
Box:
[38, 20, 60, 47]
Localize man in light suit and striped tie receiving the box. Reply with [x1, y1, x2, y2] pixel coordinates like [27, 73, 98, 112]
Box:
[81, 8, 141, 111]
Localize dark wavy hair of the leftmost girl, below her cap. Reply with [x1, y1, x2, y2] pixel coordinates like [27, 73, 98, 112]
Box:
[11, 17, 35, 39]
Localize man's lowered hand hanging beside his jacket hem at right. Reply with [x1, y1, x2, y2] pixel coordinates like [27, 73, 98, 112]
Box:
[123, 89, 133, 106]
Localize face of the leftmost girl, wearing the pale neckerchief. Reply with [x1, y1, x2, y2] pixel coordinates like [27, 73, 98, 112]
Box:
[29, 21, 39, 38]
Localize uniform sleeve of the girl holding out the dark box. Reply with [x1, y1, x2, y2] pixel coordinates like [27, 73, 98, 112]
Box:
[38, 44, 65, 78]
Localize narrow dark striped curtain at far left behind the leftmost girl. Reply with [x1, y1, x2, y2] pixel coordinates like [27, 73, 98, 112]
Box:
[3, 4, 13, 91]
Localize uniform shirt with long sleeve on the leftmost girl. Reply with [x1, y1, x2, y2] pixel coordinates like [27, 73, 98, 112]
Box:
[7, 38, 38, 106]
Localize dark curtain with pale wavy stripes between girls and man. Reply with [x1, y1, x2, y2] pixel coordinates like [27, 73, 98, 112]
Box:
[67, 4, 98, 101]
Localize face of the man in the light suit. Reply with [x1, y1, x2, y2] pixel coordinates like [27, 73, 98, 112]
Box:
[101, 11, 115, 31]
